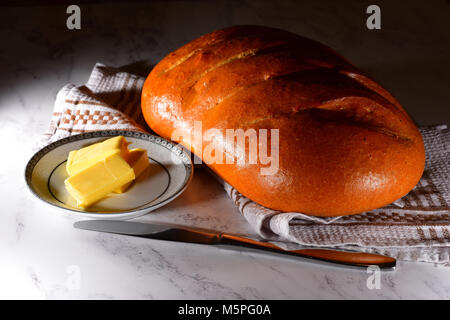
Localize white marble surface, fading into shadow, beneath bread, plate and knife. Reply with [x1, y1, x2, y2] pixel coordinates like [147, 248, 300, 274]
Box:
[0, 1, 450, 299]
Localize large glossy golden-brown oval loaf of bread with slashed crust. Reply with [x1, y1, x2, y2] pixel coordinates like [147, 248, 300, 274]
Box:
[142, 26, 425, 216]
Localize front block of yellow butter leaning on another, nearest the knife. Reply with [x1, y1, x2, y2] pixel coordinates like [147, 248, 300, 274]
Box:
[64, 152, 135, 208]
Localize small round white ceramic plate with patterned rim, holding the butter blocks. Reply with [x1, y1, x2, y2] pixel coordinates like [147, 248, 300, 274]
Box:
[25, 130, 193, 219]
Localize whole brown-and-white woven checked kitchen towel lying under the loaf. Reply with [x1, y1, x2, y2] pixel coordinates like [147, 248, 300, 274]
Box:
[38, 63, 450, 265]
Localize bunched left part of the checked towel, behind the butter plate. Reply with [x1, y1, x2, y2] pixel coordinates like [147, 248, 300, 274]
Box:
[37, 63, 149, 148]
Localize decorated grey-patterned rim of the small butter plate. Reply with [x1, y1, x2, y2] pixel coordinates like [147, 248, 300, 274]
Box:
[24, 130, 194, 218]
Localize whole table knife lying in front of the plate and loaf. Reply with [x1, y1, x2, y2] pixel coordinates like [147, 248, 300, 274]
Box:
[74, 220, 396, 270]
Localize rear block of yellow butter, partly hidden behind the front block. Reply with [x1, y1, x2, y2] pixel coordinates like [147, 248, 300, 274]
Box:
[66, 136, 130, 176]
